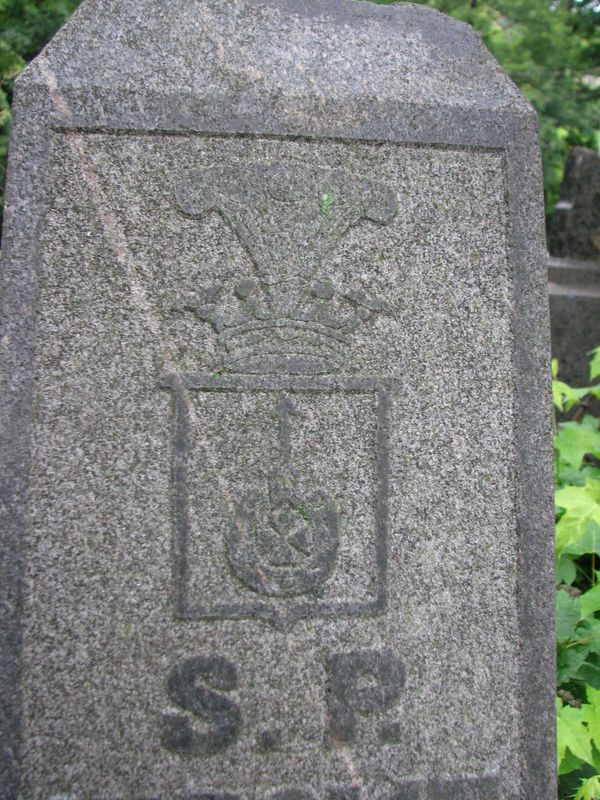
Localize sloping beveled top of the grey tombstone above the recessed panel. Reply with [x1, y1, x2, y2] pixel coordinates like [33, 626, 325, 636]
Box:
[19, 0, 531, 139]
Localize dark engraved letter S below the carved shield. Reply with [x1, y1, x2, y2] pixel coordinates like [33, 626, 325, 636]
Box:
[161, 656, 242, 756]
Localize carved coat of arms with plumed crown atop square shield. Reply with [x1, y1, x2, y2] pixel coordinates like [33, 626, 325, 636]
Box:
[163, 163, 396, 627]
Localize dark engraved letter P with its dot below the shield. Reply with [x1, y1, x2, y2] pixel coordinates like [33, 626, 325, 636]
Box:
[328, 650, 405, 742]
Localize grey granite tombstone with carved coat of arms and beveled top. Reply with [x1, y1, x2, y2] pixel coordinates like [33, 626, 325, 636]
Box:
[0, 0, 555, 800]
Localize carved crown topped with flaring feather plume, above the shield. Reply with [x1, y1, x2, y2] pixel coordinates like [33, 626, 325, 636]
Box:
[177, 163, 396, 374]
